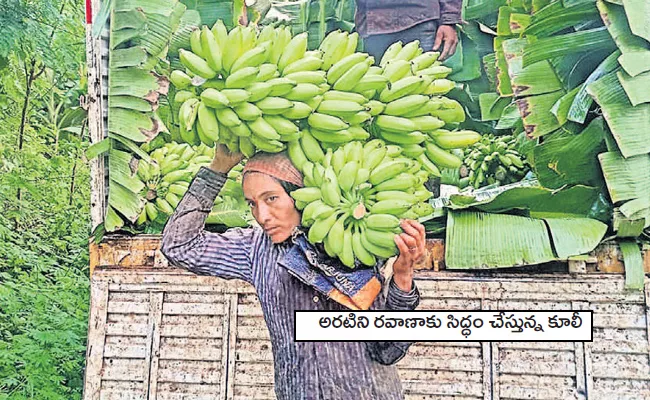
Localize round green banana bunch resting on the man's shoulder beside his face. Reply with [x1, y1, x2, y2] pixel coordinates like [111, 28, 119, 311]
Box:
[288, 138, 433, 268]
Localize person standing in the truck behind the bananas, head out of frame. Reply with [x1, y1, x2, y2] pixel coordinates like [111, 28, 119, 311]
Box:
[355, 0, 462, 60]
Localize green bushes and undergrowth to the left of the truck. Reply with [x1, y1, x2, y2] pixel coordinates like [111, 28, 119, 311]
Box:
[0, 0, 89, 400]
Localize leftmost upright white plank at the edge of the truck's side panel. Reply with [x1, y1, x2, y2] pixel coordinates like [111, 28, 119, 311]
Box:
[84, 279, 108, 400]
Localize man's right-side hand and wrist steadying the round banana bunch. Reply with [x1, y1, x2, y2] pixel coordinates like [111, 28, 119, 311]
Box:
[393, 219, 426, 292]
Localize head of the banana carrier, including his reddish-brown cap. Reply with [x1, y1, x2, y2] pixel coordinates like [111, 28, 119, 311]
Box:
[242, 153, 303, 243]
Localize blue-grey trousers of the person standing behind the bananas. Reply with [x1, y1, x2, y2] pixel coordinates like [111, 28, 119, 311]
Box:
[363, 21, 438, 63]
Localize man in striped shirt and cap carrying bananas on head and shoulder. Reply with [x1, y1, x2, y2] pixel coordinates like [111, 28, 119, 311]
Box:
[161, 144, 425, 400]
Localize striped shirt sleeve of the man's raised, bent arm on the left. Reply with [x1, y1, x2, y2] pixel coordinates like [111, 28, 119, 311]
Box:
[161, 167, 254, 283]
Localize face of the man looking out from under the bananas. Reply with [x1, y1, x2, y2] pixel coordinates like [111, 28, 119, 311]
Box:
[243, 172, 300, 243]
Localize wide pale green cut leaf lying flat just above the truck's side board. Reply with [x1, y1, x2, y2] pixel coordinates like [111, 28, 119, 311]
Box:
[445, 211, 607, 269]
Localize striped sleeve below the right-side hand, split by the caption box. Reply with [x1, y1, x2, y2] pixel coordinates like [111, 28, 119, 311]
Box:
[368, 279, 420, 365]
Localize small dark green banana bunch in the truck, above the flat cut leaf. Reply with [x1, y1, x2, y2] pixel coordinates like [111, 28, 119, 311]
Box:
[460, 135, 530, 188]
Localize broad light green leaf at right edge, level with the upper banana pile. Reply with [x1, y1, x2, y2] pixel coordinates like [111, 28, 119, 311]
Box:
[587, 73, 650, 157]
